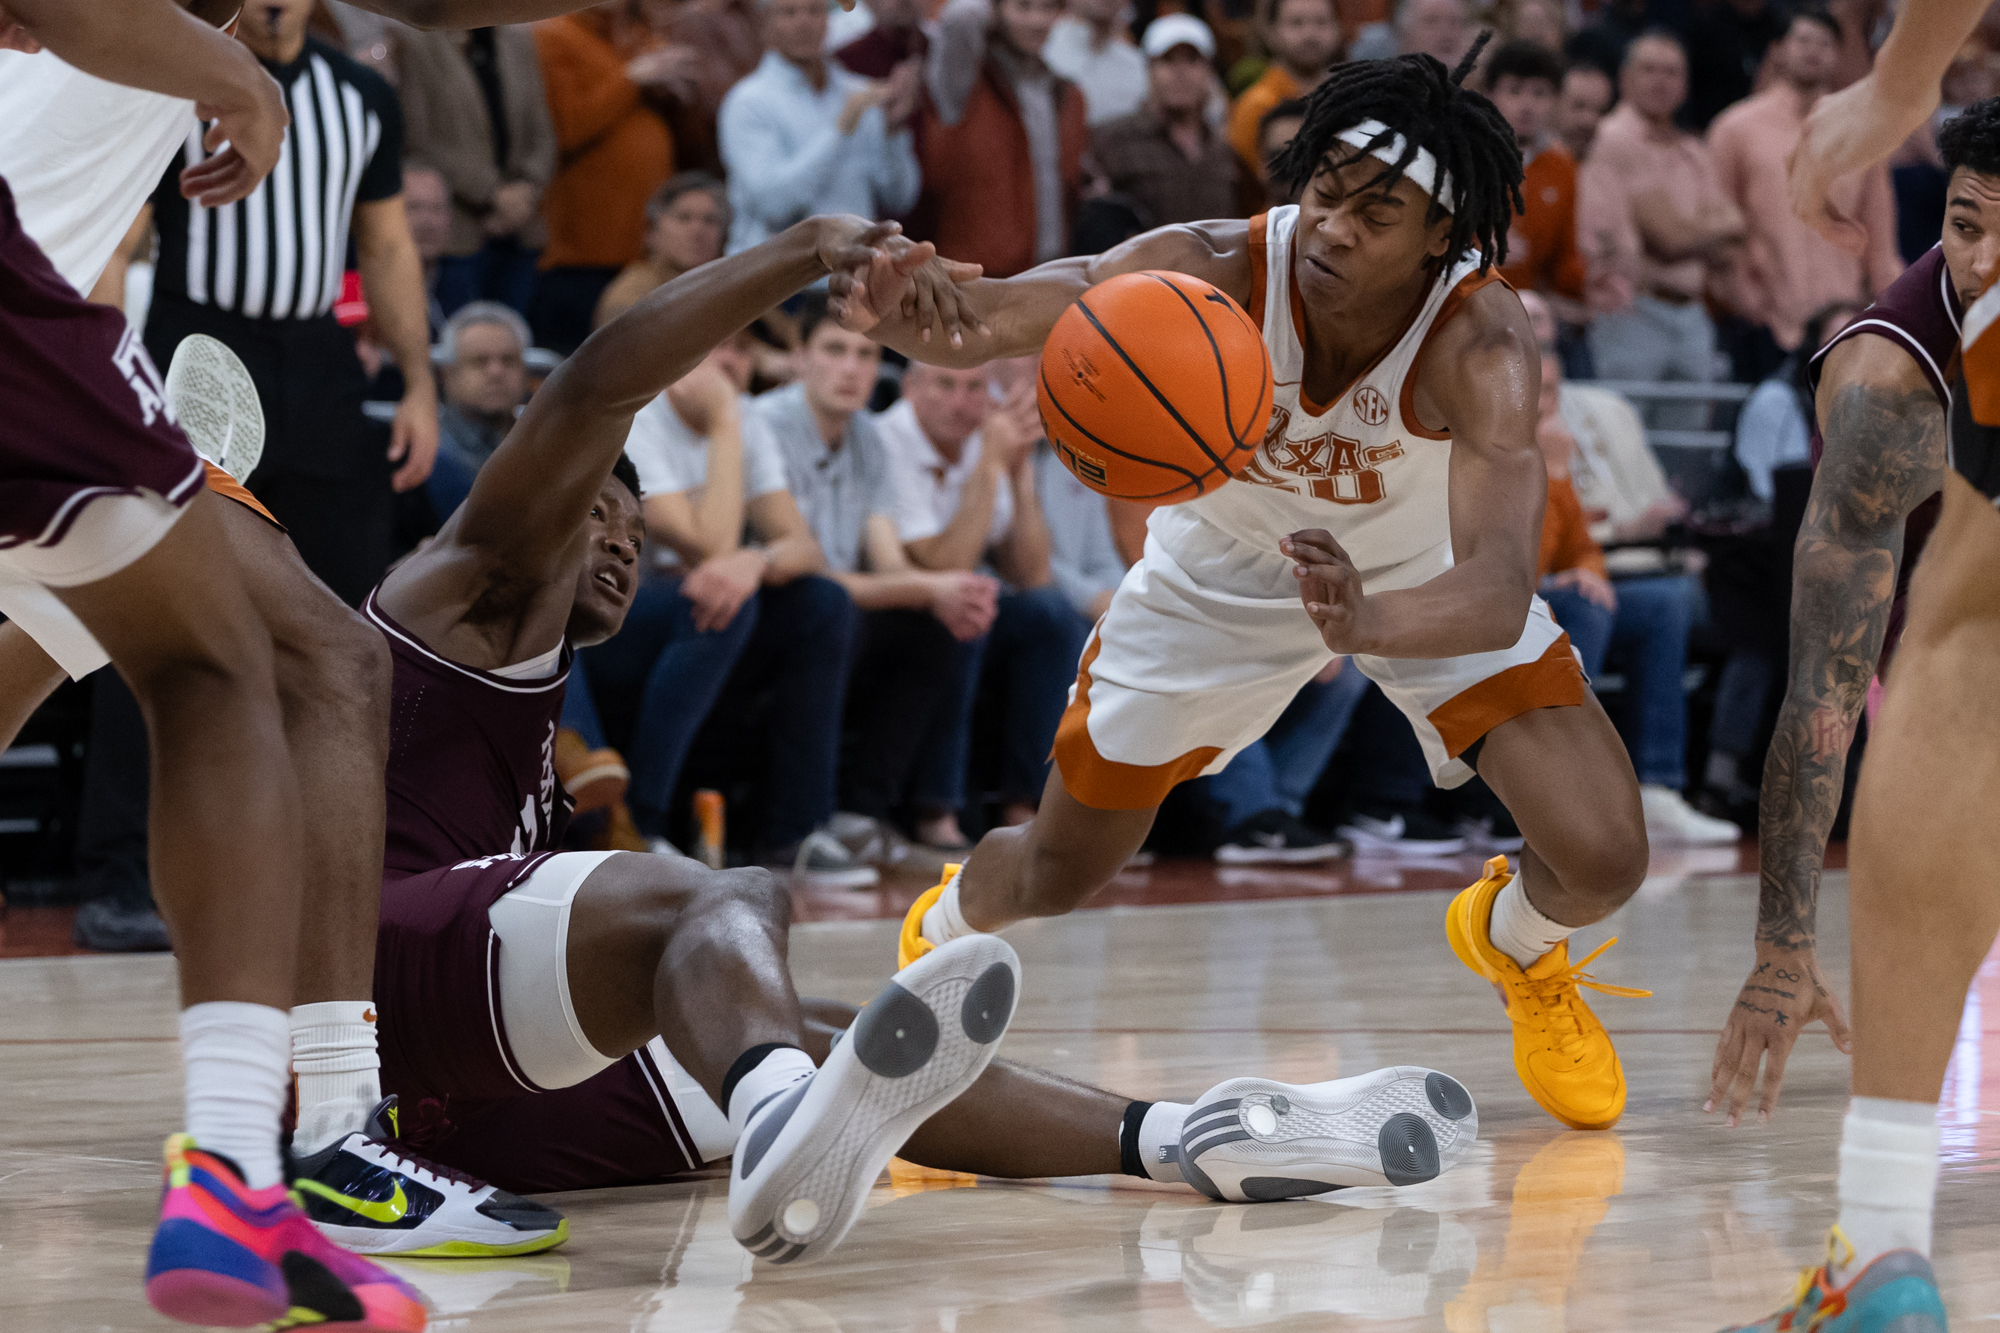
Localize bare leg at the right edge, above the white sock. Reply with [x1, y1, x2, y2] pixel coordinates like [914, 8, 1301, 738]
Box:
[1848, 472, 2000, 1101]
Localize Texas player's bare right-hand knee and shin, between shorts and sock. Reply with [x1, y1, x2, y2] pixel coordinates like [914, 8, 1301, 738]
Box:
[1478, 695, 1646, 927]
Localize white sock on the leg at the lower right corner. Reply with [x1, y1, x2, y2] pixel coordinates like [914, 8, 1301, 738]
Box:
[1834, 1097, 1938, 1285]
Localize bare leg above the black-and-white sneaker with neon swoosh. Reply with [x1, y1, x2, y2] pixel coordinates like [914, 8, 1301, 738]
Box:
[222, 502, 390, 1005]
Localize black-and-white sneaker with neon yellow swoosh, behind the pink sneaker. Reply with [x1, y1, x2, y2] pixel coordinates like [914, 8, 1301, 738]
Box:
[290, 1097, 570, 1259]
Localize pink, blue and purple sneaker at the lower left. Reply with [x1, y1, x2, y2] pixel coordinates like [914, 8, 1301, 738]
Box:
[146, 1135, 428, 1333]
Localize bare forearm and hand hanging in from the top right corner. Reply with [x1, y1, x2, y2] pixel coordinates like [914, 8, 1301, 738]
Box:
[1786, 0, 1988, 244]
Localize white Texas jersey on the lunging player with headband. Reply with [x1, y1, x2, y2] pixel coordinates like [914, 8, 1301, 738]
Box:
[1152, 206, 1500, 590]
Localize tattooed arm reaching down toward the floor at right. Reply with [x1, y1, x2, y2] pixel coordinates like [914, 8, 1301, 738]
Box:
[1702, 334, 1946, 1125]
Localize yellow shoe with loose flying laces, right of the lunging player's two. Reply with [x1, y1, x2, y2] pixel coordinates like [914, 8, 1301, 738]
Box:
[1444, 857, 1652, 1129]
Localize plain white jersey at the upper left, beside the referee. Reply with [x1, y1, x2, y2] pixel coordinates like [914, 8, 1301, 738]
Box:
[0, 50, 196, 294]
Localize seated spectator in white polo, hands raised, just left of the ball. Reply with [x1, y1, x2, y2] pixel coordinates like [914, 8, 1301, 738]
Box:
[874, 352, 1090, 847]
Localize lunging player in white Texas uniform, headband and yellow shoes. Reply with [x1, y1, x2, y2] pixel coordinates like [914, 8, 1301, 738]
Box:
[834, 46, 1646, 1129]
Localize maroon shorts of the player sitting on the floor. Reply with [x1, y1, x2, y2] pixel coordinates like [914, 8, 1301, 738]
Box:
[374, 853, 724, 1193]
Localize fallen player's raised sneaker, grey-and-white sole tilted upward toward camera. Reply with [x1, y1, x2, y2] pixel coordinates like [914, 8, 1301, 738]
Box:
[730, 935, 1020, 1263]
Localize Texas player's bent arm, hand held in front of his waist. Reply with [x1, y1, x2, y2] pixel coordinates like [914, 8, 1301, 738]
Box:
[1280, 284, 1548, 656]
